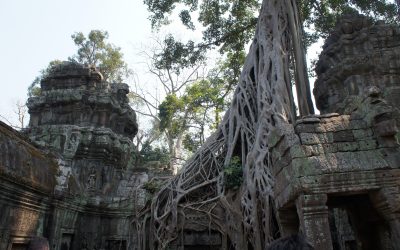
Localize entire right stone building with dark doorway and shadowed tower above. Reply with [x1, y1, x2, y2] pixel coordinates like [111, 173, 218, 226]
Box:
[269, 16, 400, 249]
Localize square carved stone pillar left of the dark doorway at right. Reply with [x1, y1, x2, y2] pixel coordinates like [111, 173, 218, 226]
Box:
[296, 194, 333, 250]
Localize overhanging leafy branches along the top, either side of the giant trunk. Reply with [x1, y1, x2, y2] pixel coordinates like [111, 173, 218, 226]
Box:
[144, 0, 397, 86]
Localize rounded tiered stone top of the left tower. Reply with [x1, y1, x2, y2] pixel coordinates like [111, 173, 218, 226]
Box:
[27, 62, 138, 138]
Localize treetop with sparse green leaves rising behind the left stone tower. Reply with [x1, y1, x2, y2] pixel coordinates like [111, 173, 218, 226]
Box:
[69, 30, 131, 82]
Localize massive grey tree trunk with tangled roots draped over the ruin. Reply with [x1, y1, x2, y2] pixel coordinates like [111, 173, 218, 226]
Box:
[136, 0, 305, 250]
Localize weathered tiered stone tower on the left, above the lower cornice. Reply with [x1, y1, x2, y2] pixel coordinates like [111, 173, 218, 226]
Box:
[26, 62, 138, 199]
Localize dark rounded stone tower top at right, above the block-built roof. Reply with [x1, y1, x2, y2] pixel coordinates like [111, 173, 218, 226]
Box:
[314, 13, 400, 114]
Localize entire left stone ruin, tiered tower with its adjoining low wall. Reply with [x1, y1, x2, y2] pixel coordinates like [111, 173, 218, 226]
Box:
[0, 62, 148, 250]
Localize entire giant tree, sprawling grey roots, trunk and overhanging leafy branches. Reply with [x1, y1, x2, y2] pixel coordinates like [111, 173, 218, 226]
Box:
[135, 0, 395, 250]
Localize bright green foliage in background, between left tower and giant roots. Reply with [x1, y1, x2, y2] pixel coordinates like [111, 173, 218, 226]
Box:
[158, 79, 226, 152]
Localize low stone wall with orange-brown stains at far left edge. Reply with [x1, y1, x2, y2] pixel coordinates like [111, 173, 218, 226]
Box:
[0, 122, 58, 249]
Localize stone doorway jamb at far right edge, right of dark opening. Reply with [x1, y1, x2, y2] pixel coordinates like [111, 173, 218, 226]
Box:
[370, 187, 400, 250]
